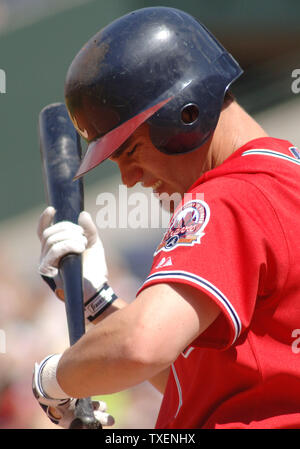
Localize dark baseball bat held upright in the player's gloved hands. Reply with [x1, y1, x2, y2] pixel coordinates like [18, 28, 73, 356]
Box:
[39, 103, 101, 429]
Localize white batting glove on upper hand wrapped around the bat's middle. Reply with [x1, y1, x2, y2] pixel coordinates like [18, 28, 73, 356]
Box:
[37, 206, 117, 321]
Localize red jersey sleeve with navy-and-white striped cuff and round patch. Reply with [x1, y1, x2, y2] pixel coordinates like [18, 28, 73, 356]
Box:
[139, 177, 289, 349]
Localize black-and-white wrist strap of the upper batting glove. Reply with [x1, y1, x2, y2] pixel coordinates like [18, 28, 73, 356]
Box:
[84, 282, 118, 322]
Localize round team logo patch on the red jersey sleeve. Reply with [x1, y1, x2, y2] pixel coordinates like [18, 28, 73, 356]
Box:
[154, 200, 210, 255]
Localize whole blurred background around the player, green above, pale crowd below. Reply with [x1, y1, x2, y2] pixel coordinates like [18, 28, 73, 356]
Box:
[0, 0, 300, 429]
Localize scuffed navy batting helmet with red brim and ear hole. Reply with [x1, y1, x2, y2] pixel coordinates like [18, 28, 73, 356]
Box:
[65, 7, 242, 177]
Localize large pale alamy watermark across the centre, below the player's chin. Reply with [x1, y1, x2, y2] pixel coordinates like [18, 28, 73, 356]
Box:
[96, 185, 204, 229]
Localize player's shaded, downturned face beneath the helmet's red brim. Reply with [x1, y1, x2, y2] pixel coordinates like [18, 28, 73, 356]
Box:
[110, 124, 210, 195]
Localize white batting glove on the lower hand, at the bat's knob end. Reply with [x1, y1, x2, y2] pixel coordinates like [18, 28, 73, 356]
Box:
[32, 354, 115, 429]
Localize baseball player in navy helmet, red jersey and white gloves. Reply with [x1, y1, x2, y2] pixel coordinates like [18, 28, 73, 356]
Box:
[34, 7, 300, 429]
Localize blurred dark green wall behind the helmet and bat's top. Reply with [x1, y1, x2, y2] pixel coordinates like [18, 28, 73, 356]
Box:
[0, 0, 300, 220]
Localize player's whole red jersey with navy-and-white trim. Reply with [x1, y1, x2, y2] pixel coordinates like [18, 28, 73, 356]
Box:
[138, 138, 300, 429]
